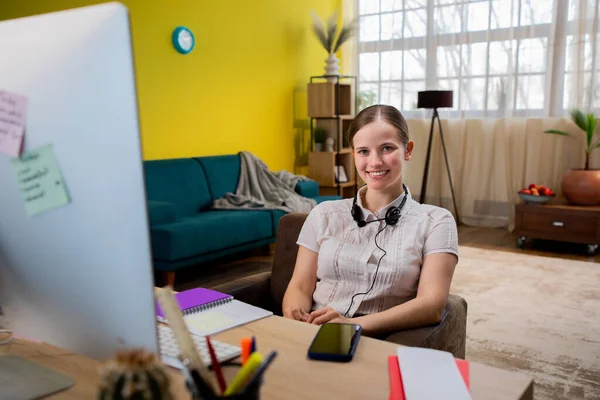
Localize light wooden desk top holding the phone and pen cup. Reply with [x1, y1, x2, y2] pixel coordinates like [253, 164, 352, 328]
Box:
[0, 316, 533, 400]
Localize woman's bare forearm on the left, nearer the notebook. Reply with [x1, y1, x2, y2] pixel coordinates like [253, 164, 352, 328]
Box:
[283, 246, 318, 321]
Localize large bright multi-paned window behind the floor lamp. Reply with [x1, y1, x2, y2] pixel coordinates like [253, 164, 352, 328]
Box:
[358, 0, 600, 117]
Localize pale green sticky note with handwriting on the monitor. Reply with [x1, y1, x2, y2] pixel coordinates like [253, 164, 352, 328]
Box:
[11, 145, 70, 217]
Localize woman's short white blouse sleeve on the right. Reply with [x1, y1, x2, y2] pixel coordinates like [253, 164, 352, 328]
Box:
[423, 209, 458, 257]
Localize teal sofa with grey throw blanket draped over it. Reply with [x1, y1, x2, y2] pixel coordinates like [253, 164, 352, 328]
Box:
[144, 154, 340, 284]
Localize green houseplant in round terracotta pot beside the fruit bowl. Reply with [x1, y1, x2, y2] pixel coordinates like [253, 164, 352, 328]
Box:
[544, 108, 600, 206]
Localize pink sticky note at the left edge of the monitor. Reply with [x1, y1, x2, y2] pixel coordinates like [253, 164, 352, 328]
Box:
[0, 90, 27, 157]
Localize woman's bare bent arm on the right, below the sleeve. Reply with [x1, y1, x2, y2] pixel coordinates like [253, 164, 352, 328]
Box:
[352, 253, 458, 334]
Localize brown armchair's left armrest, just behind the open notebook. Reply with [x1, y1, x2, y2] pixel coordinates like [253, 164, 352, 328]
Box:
[206, 272, 272, 311]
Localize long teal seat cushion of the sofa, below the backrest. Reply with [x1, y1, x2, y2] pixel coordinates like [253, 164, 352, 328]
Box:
[150, 210, 274, 261]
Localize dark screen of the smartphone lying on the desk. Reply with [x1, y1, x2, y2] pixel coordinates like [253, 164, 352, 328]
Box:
[309, 324, 361, 355]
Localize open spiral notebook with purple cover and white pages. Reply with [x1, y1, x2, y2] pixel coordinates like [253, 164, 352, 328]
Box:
[156, 288, 273, 336]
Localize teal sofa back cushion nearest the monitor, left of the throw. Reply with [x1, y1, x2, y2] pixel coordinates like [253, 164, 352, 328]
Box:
[144, 158, 212, 217]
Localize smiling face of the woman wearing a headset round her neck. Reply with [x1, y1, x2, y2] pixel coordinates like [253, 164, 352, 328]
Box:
[352, 119, 413, 191]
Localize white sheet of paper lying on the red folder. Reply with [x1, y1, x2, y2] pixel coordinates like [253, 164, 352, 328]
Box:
[396, 347, 471, 400]
